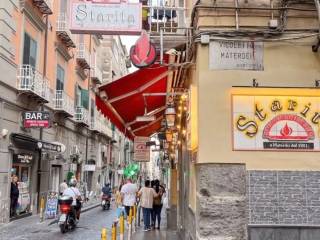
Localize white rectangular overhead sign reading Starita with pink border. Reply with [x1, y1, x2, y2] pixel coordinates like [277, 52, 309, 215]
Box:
[70, 0, 142, 35]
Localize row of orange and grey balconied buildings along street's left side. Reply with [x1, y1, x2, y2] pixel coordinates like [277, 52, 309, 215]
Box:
[0, 0, 130, 223]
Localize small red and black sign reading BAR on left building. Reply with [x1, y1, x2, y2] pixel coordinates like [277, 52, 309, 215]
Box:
[22, 111, 50, 128]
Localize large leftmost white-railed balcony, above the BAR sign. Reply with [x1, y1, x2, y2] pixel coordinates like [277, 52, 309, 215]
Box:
[17, 64, 50, 103]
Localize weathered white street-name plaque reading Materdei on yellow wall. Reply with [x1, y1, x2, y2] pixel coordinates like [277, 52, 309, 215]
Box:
[209, 41, 263, 71]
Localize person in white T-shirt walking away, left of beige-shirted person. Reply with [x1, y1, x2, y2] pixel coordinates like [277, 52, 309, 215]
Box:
[121, 178, 138, 216]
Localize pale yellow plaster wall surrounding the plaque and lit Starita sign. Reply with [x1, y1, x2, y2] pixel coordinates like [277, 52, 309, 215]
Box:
[197, 39, 320, 170]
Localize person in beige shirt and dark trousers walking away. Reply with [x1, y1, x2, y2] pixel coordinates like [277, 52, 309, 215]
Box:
[138, 180, 158, 232]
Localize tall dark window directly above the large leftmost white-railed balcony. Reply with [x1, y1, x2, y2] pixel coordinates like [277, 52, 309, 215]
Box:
[23, 33, 37, 68]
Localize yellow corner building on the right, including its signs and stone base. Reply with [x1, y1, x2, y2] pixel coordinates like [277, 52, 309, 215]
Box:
[179, 0, 320, 240]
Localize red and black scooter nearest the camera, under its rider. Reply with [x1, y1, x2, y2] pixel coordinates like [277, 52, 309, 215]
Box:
[58, 196, 77, 233]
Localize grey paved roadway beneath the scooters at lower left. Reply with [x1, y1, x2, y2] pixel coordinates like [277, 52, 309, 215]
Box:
[0, 207, 116, 240]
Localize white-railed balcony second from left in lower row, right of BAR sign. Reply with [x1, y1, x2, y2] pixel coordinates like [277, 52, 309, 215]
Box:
[53, 90, 74, 117]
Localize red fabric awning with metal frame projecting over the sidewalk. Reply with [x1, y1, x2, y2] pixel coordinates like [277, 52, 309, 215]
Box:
[96, 64, 168, 138]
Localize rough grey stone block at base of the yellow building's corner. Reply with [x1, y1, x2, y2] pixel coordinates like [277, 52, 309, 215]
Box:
[196, 164, 247, 240]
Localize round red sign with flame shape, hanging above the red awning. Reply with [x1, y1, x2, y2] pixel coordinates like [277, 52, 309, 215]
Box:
[130, 31, 157, 68]
